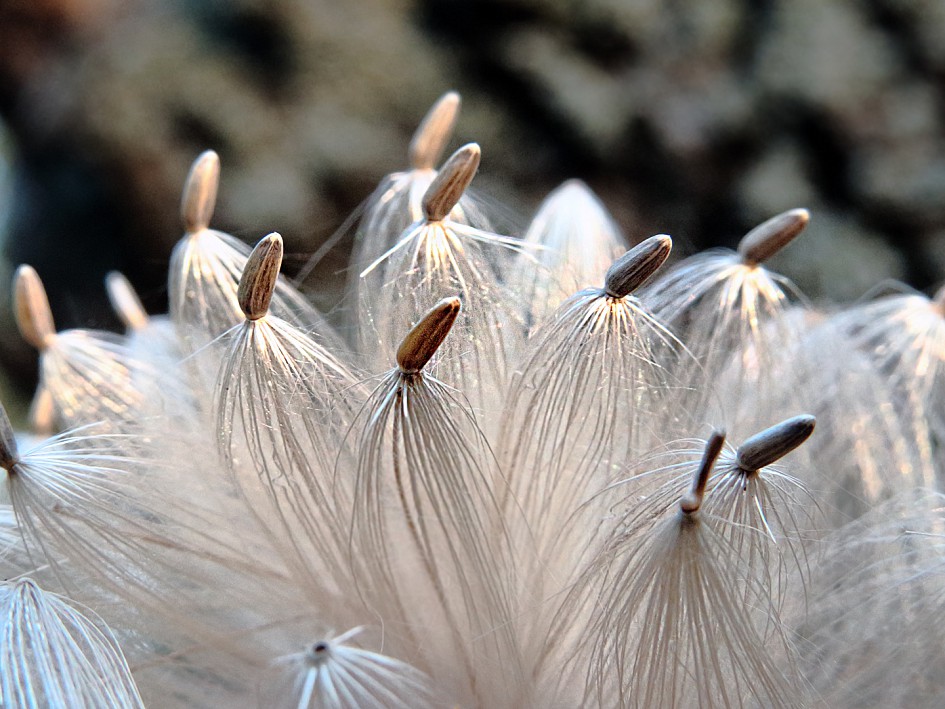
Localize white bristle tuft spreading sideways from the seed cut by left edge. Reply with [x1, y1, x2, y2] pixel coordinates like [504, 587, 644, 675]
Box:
[4, 426, 272, 612]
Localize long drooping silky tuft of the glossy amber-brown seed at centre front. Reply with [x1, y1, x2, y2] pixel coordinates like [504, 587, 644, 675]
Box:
[351, 300, 521, 704]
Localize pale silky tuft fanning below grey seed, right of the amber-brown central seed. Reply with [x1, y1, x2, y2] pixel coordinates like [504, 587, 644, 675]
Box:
[498, 238, 685, 594]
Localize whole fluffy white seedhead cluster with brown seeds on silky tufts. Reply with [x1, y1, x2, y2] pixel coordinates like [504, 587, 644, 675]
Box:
[0, 93, 945, 709]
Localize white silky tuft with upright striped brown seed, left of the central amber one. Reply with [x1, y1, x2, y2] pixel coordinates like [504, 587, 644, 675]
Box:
[215, 254, 362, 594]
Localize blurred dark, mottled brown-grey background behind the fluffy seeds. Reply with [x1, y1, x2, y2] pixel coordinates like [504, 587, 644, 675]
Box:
[0, 0, 945, 410]
